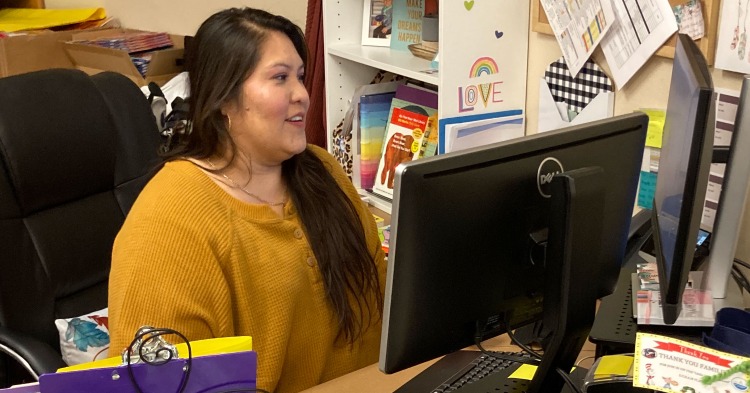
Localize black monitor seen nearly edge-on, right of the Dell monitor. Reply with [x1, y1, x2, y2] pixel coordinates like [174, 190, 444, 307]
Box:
[652, 34, 715, 324]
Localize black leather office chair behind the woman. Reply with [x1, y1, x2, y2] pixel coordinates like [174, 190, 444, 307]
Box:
[0, 69, 161, 387]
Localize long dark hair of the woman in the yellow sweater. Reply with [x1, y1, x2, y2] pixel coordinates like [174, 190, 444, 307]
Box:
[167, 8, 383, 343]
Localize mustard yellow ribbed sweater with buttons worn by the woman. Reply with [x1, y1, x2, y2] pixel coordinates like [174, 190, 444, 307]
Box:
[109, 145, 385, 392]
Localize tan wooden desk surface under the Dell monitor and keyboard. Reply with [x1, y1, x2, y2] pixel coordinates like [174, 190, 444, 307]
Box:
[304, 335, 595, 393]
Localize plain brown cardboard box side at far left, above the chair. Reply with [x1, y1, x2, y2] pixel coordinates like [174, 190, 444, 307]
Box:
[0, 31, 75, 77]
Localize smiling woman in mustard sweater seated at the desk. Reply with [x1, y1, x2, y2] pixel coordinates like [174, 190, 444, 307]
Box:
[109, 8, 385, 392]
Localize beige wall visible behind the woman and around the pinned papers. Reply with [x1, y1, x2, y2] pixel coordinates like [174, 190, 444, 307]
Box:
[46, 0, 750, 286]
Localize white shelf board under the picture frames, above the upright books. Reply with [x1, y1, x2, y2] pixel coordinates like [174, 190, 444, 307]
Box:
[328, 44, 438, 86]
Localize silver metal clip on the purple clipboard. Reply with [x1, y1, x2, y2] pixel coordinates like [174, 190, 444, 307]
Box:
[122, 326, 184, 365]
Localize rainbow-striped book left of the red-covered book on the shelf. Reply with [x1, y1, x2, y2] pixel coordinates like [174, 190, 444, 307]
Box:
[355, 91, 396, 190]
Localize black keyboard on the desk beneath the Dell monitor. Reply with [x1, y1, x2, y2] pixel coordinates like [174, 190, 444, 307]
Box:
[396, 351, 533, 393]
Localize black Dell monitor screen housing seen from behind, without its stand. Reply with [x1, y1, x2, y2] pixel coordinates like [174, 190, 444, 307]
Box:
[379, 113, 648, 388]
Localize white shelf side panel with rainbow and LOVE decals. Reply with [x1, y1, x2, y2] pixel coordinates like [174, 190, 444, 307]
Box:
[438, 0, 536, 153]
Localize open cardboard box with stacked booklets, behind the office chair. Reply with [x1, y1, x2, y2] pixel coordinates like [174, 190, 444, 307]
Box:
[63, 29, 185, 86]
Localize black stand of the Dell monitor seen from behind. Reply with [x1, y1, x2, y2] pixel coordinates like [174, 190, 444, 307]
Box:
[456, 167, 617, 393]
